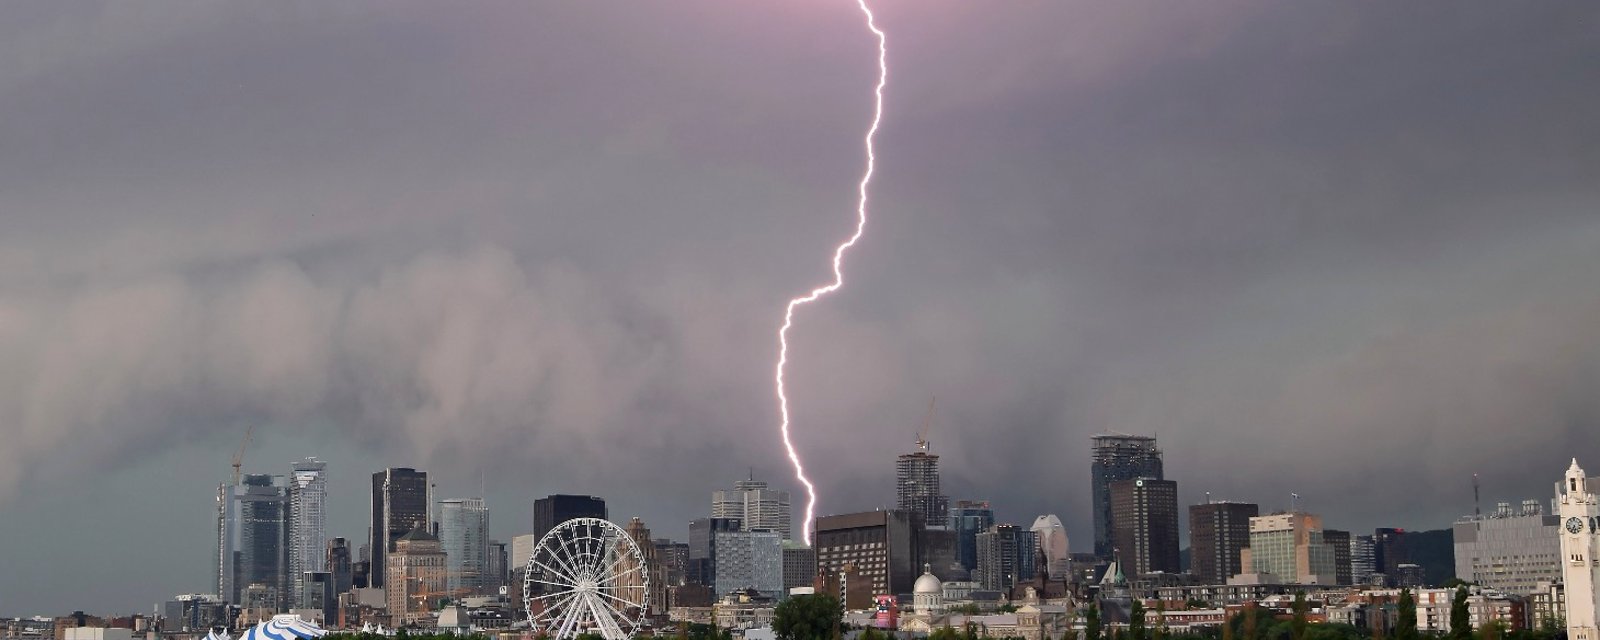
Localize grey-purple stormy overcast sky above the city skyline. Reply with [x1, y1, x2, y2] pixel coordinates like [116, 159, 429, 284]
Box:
[0, 0, 1600, 614]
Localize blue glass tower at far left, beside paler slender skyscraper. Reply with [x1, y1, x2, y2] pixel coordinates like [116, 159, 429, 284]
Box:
[216, 474, 291, 610]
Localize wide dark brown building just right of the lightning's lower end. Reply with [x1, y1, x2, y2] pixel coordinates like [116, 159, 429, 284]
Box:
[813, 509, 922, 594]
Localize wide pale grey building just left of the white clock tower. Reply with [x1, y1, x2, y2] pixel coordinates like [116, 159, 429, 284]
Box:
[1451, 499, 1562, 597]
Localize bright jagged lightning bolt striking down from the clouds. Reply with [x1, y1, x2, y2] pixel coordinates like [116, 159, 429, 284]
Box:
[774, 0, 890, 544]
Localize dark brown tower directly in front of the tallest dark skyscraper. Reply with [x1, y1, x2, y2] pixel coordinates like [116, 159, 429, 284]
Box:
[1109, 478, 1184, 576]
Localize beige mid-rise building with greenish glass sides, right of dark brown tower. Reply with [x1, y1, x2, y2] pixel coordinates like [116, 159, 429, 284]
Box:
[1242, 512, 1338, 584]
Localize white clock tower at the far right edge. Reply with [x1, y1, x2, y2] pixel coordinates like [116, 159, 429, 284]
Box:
[1555, 458, 1600, 640]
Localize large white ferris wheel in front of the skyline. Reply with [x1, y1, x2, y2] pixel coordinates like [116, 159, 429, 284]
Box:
[522, 518, 650, 640]
